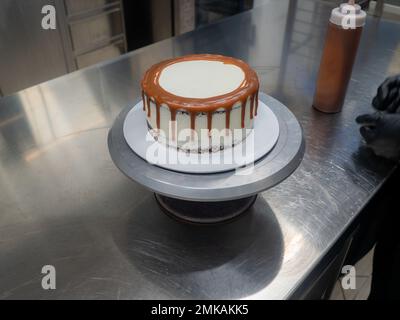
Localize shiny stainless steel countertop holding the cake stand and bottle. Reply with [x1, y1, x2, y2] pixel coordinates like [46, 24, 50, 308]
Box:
[0, 0, 400, 299]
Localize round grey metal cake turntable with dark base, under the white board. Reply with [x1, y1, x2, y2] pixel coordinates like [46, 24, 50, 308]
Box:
[108, 93, 305, 223]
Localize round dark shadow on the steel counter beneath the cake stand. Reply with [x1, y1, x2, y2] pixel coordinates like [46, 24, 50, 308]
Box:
[113, 197, 284, 299]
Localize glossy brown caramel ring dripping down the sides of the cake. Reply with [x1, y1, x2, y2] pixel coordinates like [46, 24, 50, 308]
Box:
[141, 54, 259, 130]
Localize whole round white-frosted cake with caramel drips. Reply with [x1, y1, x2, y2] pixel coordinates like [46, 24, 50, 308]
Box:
[141, 54, 259, 152]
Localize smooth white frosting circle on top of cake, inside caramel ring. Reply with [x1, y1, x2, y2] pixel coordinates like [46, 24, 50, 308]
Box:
[159, 60, 245, 99]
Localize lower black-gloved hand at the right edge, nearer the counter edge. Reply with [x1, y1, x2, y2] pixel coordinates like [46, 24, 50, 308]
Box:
[356, 112, 400, 160]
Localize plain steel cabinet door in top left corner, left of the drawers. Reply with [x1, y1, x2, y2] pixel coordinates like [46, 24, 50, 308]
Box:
[0, 0, 67, 95]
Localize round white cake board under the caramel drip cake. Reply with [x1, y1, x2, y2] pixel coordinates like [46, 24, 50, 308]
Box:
[123, 101, 279, 174]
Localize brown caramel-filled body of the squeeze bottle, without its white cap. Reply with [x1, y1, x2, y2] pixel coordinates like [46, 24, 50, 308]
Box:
[313, 2, 363, 113]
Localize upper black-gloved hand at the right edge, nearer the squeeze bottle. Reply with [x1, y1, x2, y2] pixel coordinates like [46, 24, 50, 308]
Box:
[372, 75, 400, 113]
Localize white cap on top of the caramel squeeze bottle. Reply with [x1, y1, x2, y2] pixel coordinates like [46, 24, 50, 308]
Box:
[329, 3, 367, 29]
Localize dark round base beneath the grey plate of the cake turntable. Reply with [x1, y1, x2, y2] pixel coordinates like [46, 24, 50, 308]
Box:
[154, 193, 257, 224]
